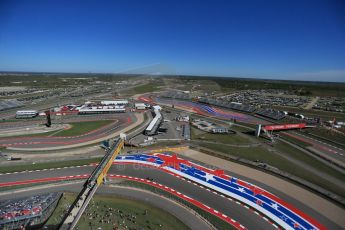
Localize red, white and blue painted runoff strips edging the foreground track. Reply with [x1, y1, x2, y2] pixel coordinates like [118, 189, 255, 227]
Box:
[0, 153, 326, 229]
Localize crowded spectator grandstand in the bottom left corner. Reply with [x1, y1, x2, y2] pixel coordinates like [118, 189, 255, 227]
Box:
[0, 193, 62, 230]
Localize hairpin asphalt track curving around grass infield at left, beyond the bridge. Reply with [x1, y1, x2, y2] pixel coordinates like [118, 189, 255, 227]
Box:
[0, 113, 136, 148]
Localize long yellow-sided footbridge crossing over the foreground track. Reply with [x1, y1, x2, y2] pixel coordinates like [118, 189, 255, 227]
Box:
[59, 139, 124, 230]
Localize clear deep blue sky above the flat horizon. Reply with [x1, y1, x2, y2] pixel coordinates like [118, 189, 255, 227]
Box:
[0, 0, 345, 81]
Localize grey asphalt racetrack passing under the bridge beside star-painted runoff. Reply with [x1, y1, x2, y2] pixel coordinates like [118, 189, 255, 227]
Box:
[0, 165, 275, 229]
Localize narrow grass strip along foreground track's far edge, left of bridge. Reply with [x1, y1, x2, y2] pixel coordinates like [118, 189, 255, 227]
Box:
[0, 158, 101, 173]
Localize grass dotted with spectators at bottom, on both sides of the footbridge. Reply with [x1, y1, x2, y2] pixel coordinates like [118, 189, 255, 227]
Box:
[46, 193, 188, 230]
